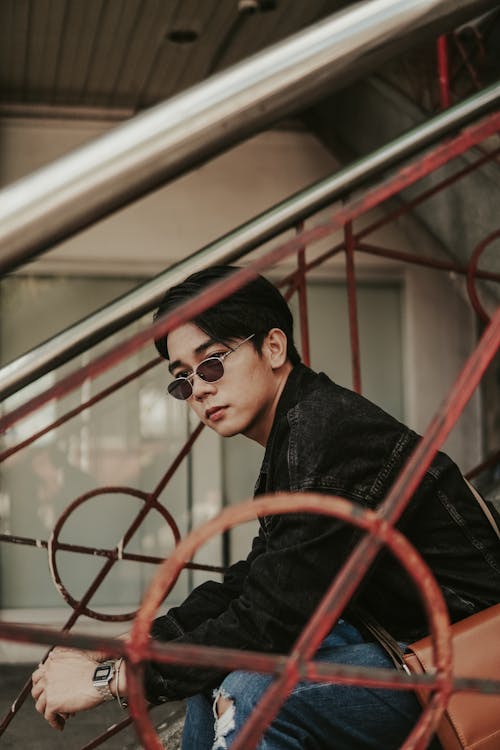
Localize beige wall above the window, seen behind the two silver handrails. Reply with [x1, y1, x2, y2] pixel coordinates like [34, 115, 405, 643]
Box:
[0, 120, 336, 276]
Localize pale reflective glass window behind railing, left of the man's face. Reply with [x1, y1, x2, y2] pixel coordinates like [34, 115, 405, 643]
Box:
[0, 276, 221, 614]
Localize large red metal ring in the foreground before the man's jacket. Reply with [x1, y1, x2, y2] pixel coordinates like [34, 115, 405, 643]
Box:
[126, 493, 452, 750]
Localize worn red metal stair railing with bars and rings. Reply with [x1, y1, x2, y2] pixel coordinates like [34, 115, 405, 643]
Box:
[0, 53, 500, 750]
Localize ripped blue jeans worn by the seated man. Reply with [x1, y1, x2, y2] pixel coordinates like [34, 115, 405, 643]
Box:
[182, 620, 439, 750]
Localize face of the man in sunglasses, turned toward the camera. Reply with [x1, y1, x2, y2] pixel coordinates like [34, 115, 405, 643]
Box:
[167, 323, 291, 445]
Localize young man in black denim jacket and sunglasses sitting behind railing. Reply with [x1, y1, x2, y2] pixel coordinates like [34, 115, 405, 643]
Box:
[33, 267, 500, 750]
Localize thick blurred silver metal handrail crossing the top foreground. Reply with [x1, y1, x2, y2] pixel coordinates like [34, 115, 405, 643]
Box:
[0, 0, 497, 280]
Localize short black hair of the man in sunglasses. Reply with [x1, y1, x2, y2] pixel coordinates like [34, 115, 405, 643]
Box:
[154, 266, 300, 365]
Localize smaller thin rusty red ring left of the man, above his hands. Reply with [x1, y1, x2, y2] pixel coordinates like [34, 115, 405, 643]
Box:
[47, 487, 181, 622]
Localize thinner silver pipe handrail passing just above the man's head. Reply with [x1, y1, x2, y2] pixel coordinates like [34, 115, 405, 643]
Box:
[0, 84, 500, 399]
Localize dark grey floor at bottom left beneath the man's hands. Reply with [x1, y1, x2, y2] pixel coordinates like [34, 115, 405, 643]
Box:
[0, 664, 183, 750]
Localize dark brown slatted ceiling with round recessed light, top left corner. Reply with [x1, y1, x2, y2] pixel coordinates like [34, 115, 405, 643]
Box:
[0, 0, 349, 115]
